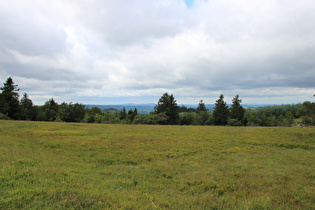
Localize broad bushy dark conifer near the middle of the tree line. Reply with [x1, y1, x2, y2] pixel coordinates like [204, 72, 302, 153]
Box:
[155, 93, 179, 125]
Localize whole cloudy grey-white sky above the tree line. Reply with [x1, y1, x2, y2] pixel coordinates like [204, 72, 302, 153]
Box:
[0, 0, 315, 105]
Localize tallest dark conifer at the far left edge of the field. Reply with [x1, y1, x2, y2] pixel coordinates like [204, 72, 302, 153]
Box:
[0, 77, 21, 119]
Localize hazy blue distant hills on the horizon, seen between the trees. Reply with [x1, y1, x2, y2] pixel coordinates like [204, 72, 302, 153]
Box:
[85, 103, 268, 114]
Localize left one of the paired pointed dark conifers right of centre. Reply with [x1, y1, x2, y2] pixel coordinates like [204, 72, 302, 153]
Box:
[213, 94, 229, 125]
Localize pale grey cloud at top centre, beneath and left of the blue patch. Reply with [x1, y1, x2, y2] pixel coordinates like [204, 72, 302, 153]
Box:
[77, 0, 192, 46]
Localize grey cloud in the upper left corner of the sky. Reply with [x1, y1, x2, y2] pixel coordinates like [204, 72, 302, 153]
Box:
[0, 3, 66, 56]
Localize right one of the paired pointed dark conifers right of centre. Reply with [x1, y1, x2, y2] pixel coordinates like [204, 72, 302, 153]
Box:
[229, 95, 245, 125]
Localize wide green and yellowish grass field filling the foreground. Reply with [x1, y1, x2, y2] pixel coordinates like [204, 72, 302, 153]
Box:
[0, 121, 315, 209]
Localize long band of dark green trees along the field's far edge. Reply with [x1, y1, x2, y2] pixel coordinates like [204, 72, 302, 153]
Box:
[0, 77, 315, 126]
